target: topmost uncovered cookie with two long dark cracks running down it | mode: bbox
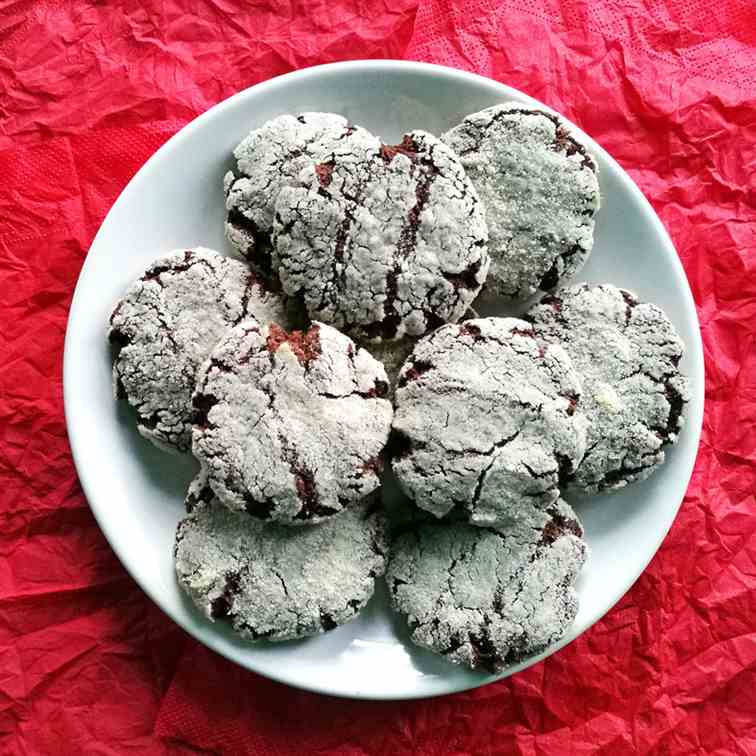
[273,131,488,341]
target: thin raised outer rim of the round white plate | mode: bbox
[63,59,705,701]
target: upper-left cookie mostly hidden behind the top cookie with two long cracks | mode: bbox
[223,113,380,269]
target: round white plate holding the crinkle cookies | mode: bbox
[64,61,704,698]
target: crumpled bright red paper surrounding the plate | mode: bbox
[0,0,756,756]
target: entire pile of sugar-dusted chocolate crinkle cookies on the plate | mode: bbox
[109,103,688,671]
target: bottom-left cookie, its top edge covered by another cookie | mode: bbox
[174,483,387,640]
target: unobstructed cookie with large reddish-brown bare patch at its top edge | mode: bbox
[192,320,393,524]
